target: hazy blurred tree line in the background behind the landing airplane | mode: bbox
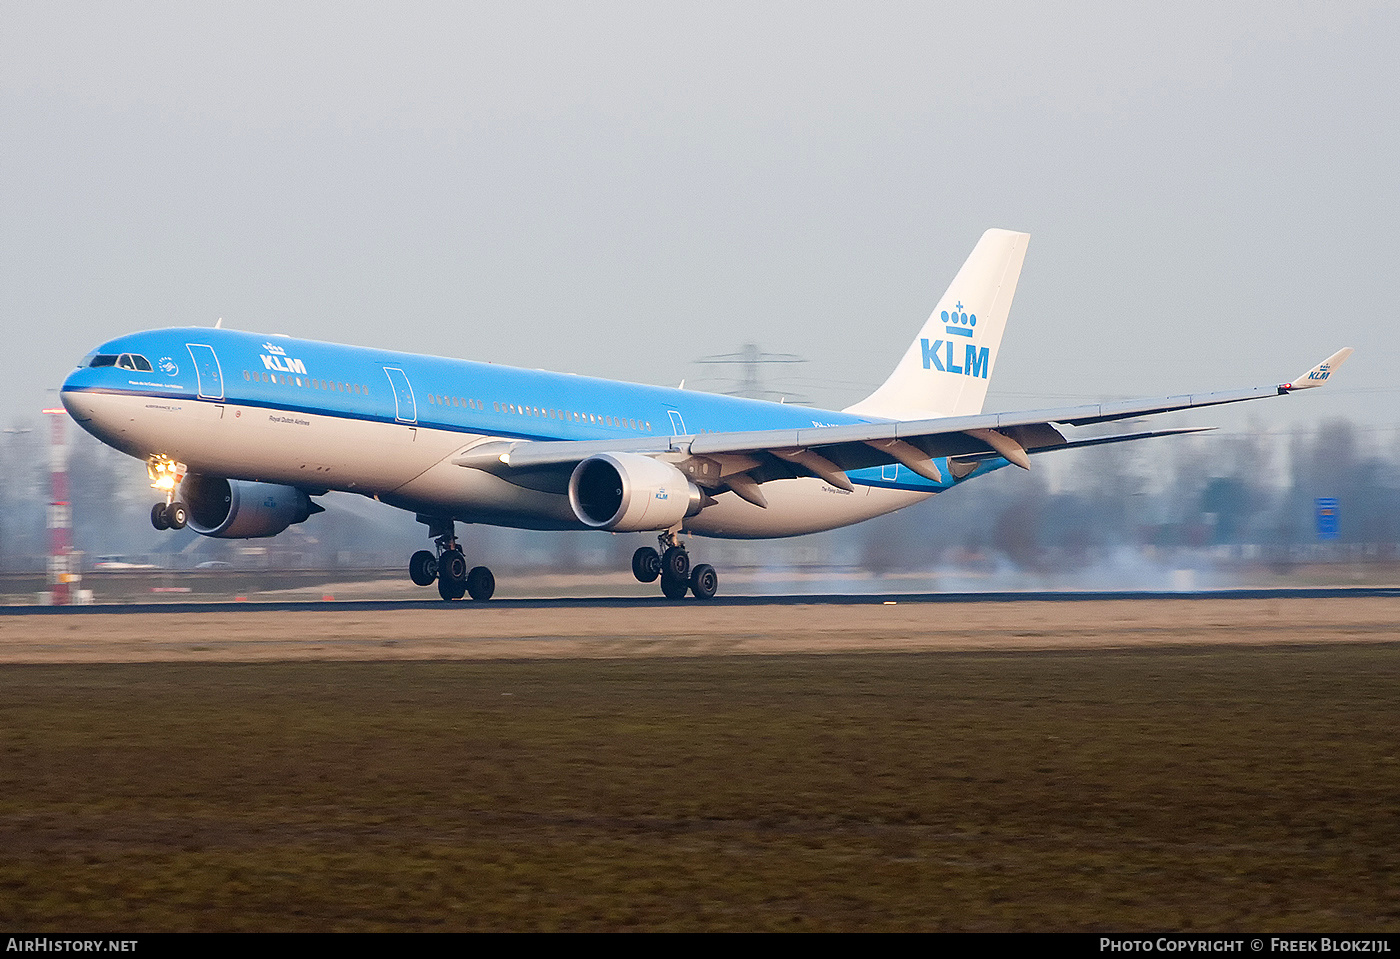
[0,420,1400,573]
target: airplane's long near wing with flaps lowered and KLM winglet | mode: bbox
[452,347,1351,500]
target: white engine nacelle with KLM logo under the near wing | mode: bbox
[568,452,704,533]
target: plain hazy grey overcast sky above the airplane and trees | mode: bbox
[0,0,1400,428]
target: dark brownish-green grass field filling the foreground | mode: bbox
[0,643,1400,931]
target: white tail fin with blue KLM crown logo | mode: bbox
[846,230,1030,420]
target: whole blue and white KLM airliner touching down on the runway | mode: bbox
[62,230,1351,601]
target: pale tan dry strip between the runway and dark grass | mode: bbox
[0,598,1400,662]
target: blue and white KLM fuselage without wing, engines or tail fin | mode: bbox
[63,328,963,538]
